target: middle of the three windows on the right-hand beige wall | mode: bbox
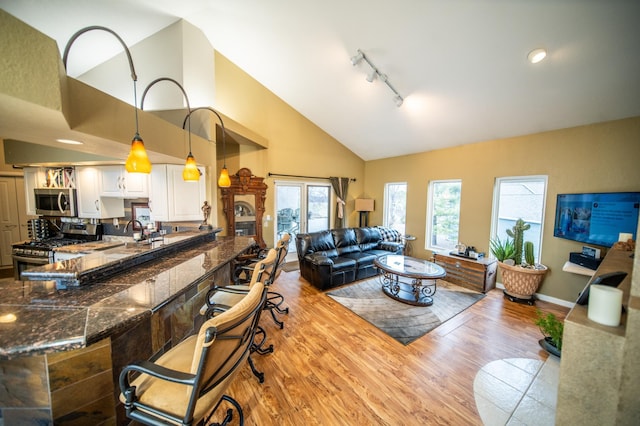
[426,180,462,250]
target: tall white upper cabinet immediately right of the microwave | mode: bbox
[76,167,124,219]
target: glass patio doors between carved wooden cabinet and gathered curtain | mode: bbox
[274,182,332,261]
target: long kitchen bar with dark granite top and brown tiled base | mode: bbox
[0,231,255,426]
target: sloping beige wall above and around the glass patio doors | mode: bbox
[214,53,364,246]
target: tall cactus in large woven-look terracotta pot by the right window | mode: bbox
[490,219,548,305]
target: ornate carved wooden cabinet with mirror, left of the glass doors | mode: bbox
[221,168,267,247]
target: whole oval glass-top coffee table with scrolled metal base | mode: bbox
[373,254,447,306]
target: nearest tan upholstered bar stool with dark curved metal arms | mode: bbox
[120,282,266,425]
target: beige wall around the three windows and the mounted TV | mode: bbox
[364,117,640,301]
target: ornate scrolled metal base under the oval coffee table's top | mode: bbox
[379,272,436,306]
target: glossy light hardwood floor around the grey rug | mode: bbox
[222,271,568,425]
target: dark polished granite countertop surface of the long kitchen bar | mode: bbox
[0,233,254,359]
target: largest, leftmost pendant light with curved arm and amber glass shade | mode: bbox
[62,25,151,173]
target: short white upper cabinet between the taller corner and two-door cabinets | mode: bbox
[98,166,149,198]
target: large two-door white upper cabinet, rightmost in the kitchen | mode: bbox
[149,164,206,222]
